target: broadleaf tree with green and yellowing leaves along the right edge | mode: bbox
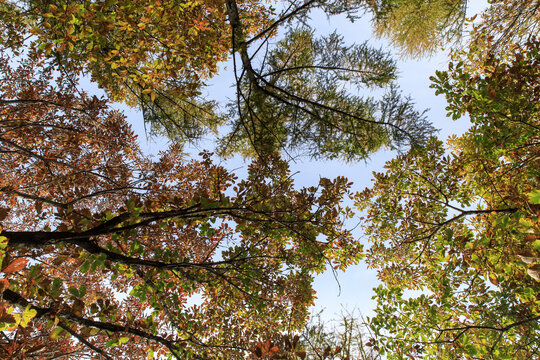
[357,37,540,359]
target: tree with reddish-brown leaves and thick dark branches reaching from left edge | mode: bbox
[0,54,361,359]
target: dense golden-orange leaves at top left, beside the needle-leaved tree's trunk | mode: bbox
[13,0,268,100]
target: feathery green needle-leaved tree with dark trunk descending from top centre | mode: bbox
[221,0,434,160]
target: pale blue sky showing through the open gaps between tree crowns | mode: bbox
[121,0,487,320]
